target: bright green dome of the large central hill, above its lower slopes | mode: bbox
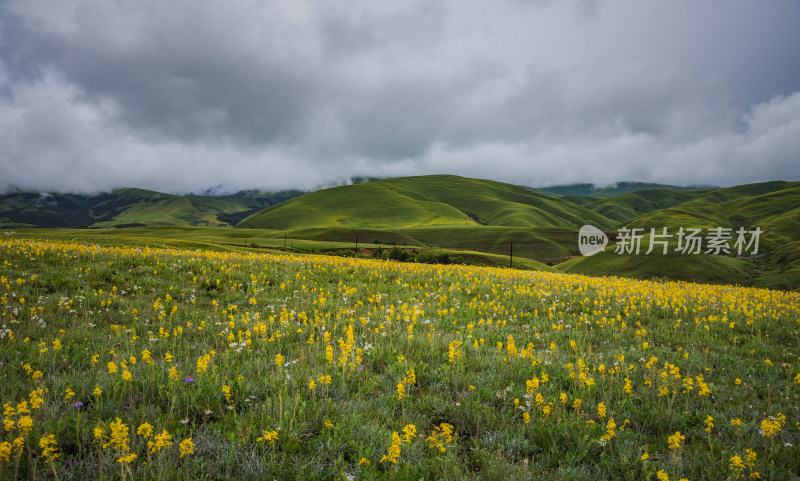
[237,175,612,230]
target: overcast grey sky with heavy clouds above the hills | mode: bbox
[0,0,800,193]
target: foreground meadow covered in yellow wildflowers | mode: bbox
[0,233,800,481]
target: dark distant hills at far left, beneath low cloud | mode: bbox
[0,188,301,228]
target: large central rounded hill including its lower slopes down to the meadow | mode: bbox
[237,175,615,264]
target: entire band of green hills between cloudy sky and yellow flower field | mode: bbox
[7,175,800,289]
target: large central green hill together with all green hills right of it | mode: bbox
[237,176,800,289]
